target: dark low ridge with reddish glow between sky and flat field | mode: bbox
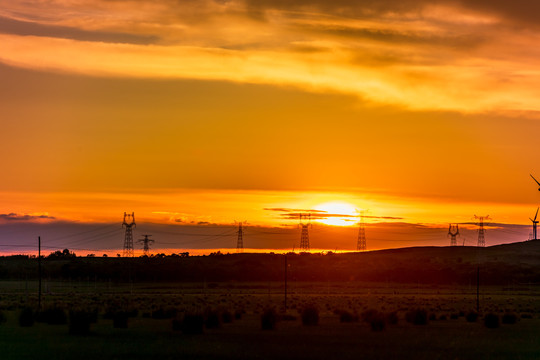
[0,241,540,285]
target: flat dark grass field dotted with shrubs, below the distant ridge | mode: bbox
[0,282,540,359]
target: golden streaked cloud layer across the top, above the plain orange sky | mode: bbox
[0,0,540,112]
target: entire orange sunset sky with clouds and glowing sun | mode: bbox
[0,0,540,252]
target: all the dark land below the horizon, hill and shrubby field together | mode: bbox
[0,241,540,360]
